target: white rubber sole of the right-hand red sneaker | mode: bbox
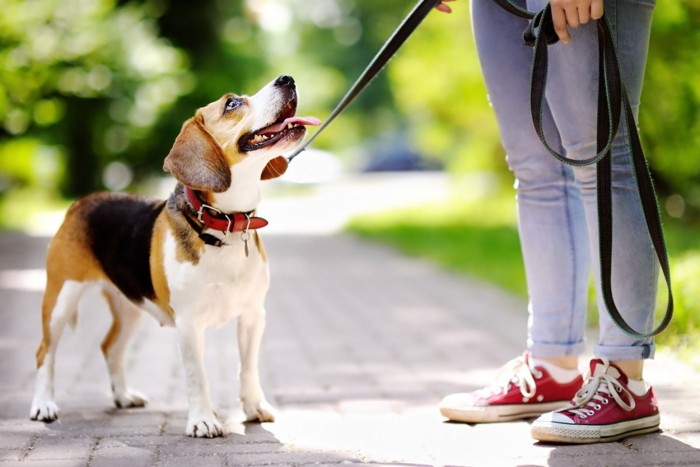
[531,414,661,444]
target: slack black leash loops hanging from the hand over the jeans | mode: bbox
[494,0,673,339]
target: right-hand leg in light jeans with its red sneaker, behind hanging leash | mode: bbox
[532,0,659,443]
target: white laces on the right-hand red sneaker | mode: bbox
[559,360,636,418]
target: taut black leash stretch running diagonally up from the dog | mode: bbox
[287,0,440,162]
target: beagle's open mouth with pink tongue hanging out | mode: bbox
[239,101,321,152]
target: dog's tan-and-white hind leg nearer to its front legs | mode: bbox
[102,287,146,409]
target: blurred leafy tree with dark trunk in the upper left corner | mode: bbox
[0,0,191,195]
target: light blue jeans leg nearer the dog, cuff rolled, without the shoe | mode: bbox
[472,0,590,365]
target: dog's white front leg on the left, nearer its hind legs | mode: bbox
[177,321,223,438]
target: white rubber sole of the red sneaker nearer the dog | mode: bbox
[440,400,569,423]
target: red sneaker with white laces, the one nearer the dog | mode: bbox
[440,352,583,423]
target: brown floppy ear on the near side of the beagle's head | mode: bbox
[163,114,231,193]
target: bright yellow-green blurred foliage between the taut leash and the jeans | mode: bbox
[389,5,505,173]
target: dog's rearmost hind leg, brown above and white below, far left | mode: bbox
[29,275,85,422]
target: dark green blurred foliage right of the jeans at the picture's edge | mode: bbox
[640,0,700,216]
